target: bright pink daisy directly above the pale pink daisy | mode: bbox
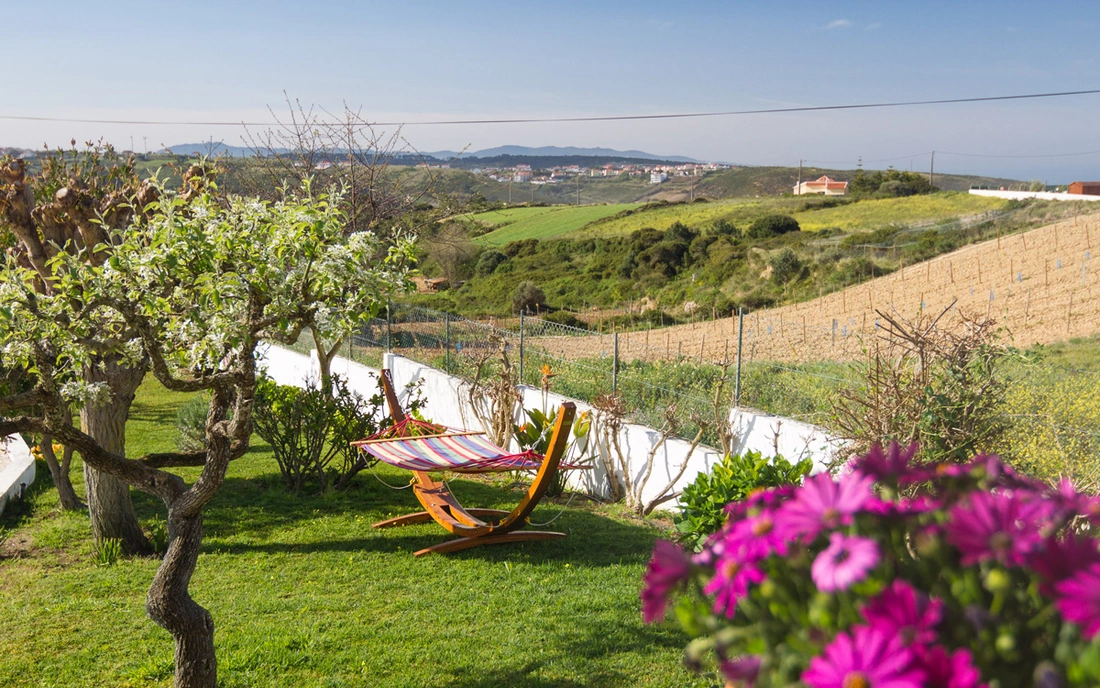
[776,472,875,542]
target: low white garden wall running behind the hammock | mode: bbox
[263,347,840,507]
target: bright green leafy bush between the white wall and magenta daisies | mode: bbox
[675,451,813,550]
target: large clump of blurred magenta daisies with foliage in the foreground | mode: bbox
[641,444,1100,688]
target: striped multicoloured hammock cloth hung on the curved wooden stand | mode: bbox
[353,418,581,473]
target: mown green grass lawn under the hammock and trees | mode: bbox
[0,382,705,687]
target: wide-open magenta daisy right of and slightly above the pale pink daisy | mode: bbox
[946,491,1052,566]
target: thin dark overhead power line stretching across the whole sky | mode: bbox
[0,89,1100,127]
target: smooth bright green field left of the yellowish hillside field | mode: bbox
[470,204,638,245]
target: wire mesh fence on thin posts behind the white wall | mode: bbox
[327,297,1100,478]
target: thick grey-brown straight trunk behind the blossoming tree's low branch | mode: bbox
[80,363,153,555]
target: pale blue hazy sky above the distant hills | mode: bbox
[8,0,1100,184]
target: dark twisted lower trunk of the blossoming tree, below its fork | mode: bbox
[145,507,218,688]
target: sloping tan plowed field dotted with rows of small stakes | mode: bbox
[529,215,1100,361]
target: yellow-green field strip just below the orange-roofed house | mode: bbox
[794,192,1008,231]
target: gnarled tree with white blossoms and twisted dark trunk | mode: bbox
[0,167,410,688]
